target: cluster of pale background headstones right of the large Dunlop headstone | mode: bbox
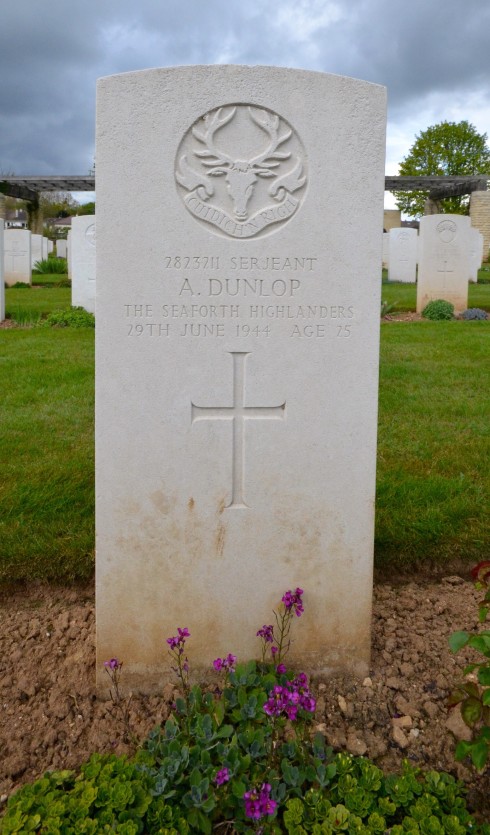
[383,215,484,312]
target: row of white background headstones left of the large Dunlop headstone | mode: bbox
[0,215,95,319]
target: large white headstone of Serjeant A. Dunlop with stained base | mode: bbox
[96,66,385,691]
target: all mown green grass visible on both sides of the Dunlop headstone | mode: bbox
[0,285,490,582]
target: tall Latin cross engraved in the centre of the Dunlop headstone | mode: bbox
[191,351,286,508]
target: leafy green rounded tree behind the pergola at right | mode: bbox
[396,121,490,217]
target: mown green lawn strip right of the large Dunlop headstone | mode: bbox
[376,321,490,569]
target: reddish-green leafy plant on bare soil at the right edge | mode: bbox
[449,560,490,771]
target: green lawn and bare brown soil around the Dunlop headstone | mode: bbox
[0,276,490,820]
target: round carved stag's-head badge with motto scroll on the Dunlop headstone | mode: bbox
[175,104,307,238]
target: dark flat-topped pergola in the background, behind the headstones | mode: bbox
[0,174,488,232]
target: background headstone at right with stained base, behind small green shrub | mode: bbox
[417,214,471,313]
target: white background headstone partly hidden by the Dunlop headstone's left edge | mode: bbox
[70,215,95,313]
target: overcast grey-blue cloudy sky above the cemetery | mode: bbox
[0,0,490,206]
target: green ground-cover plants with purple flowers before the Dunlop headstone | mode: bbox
[1,588,490,835]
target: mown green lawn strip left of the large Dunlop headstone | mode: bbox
[0,326,94,581]
